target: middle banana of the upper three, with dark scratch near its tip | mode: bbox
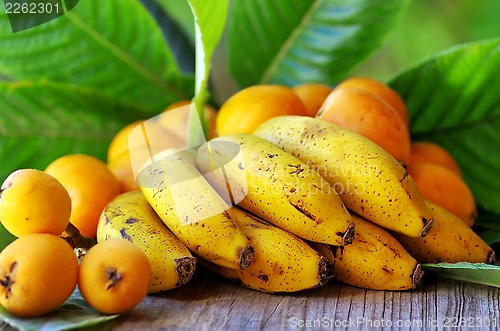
[196,134,354,245]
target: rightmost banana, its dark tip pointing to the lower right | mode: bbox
[394,201,495,263]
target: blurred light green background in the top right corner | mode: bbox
[354,0,500,80]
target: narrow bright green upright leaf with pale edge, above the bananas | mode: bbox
[188,0,229,146]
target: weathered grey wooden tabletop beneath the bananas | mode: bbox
[0,270,500,331]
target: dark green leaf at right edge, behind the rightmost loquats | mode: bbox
[389,39,500,214]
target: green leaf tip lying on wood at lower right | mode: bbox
[422,262,500,287]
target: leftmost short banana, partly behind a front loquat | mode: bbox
[97,191,196,293]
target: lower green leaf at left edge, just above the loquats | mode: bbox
[0,81,145,182]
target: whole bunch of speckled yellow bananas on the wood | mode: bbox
[98,116,494,293]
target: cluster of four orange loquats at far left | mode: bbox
[0,160,151,317]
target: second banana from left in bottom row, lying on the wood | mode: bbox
[200,208,334,293]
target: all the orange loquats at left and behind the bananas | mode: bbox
[0,77,477,317]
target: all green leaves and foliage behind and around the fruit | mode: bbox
[0,0,500,329]
